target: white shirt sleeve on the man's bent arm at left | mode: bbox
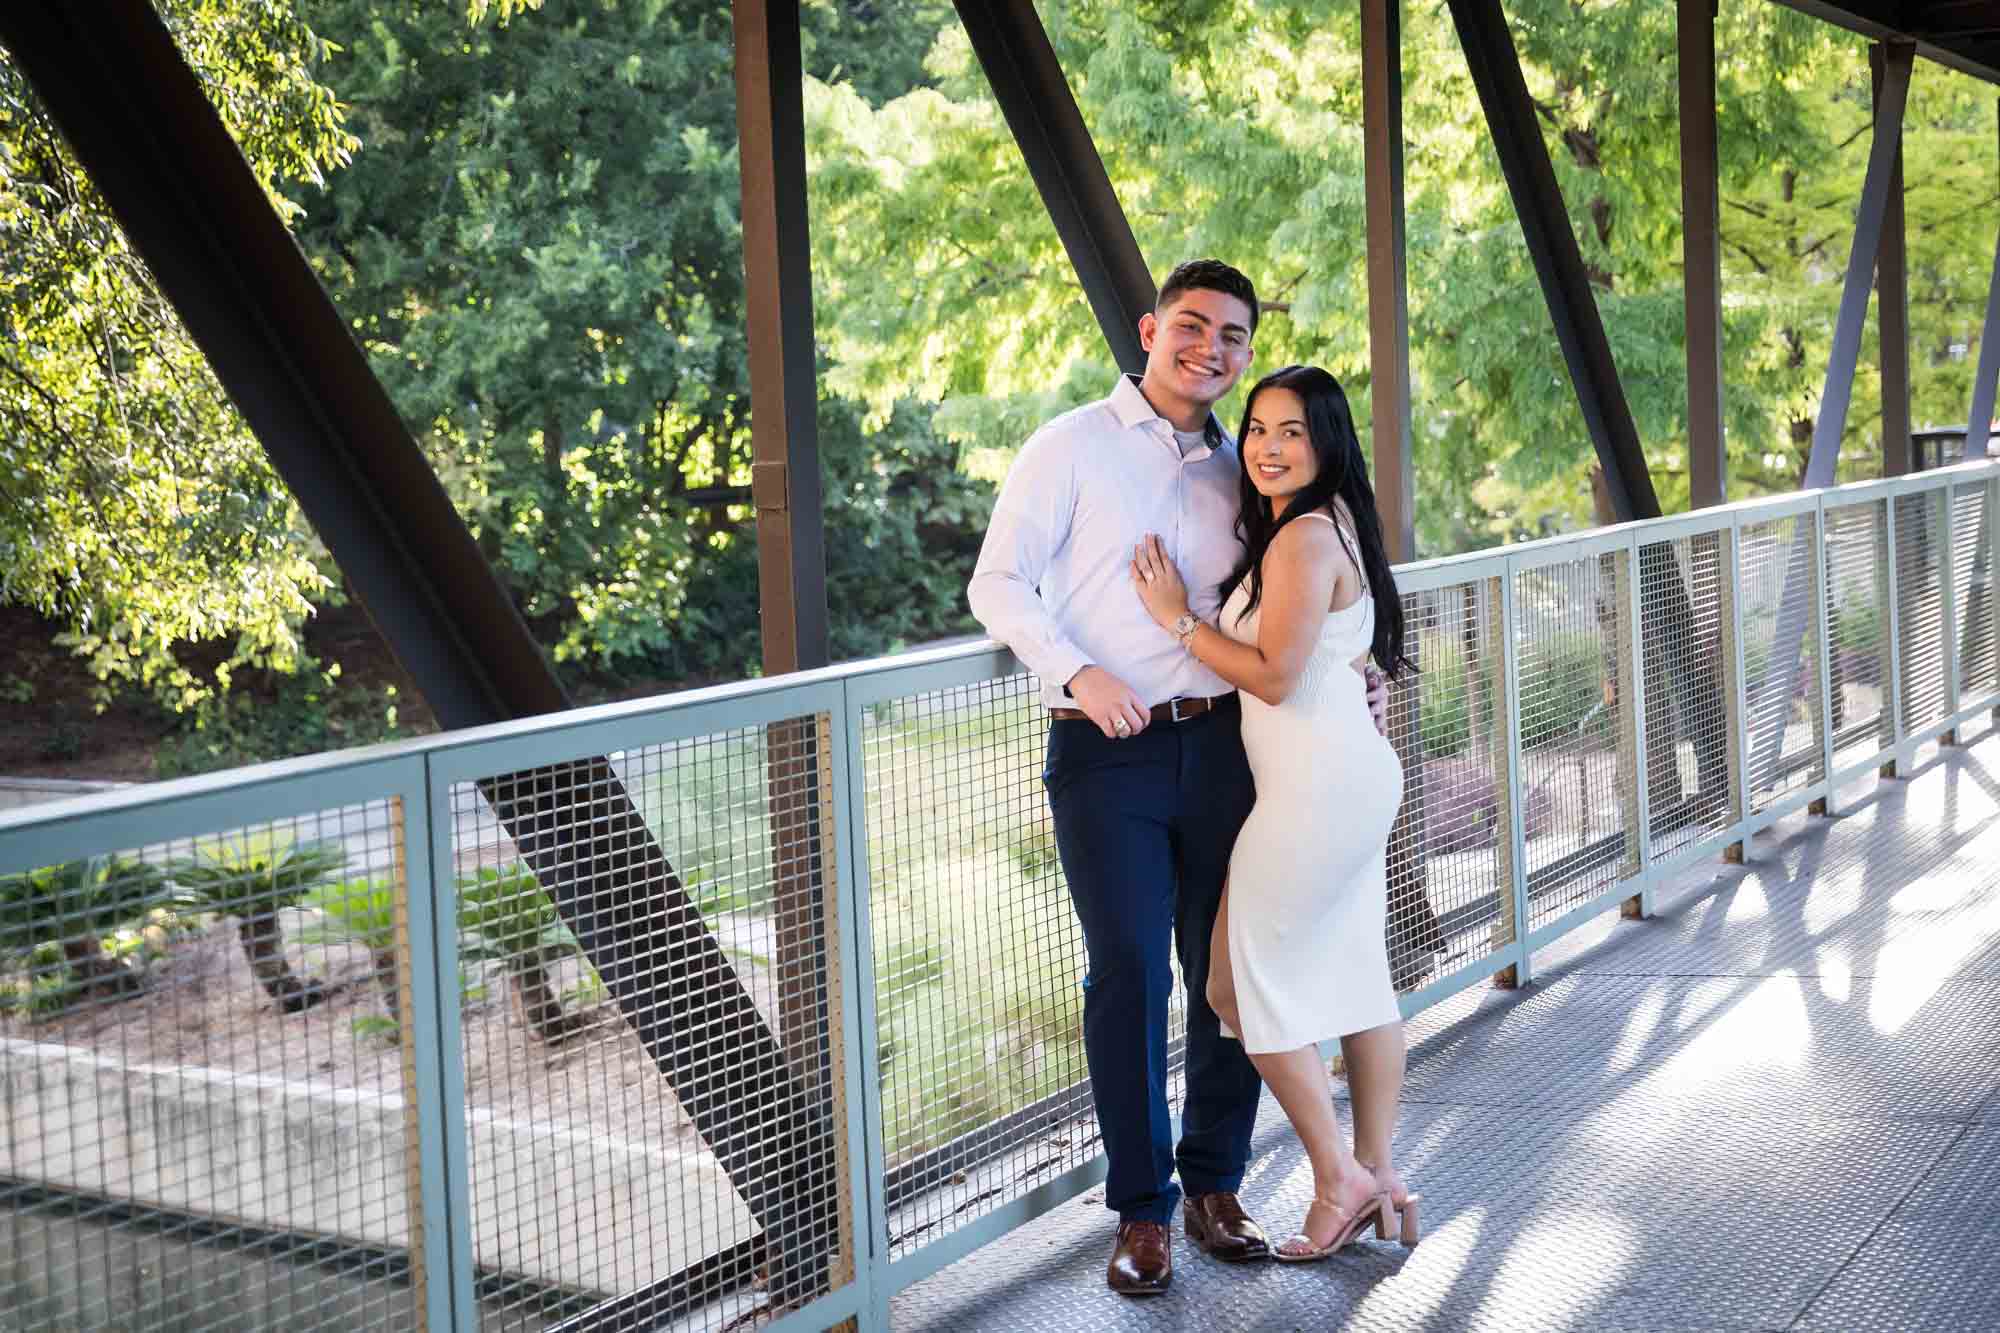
[966,434,1090,685]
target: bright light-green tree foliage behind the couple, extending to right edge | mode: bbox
[808,0,1992,552]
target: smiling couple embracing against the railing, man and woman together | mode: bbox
[970,260,1418,1295]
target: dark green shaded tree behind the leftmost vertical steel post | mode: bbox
[298,0,982,675]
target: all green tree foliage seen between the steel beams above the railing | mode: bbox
[0,0,1994,728]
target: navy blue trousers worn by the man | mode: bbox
[1042,703,1262,1223]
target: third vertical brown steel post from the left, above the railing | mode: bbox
[1676,0,1730,508]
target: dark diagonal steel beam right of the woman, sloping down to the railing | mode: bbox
[1450,0,1660,520]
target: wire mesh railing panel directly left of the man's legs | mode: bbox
[862,675,1112,1257]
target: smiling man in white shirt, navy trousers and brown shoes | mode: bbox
[968,260,1382,1295]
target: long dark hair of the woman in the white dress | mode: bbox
[1222,366,1416,677]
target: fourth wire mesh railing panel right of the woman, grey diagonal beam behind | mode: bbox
[1738,510,1826,811]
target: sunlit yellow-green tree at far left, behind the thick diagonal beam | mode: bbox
[0,0,354,707]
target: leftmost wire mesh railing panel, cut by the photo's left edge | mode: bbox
[0,799,426,1333]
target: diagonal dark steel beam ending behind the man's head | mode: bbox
[954,0,1158,374]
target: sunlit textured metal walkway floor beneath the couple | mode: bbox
[894,731,2000,1333]
